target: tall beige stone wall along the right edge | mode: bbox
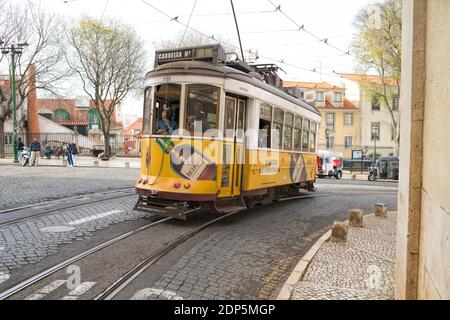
[396,0,450,299]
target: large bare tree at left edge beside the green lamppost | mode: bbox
[0,0,67,157]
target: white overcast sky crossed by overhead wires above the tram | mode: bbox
[42,0,373,114]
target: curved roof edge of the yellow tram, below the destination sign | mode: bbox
[146,61,320,115]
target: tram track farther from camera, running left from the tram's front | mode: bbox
[0,188,136,228]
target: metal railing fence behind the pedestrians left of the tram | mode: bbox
[3,132,141,157]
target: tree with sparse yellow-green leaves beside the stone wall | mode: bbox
[352,0,402,153]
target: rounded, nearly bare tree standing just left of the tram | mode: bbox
[66,18,146,158]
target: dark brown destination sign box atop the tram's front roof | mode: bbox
[155,44,225,67]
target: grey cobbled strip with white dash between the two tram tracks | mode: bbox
[0,197,143,273]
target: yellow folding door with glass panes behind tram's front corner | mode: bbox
[219,97,246,197]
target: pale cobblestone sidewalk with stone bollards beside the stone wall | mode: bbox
[291,212,397,300]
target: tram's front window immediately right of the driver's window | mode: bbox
[186,85,219,135]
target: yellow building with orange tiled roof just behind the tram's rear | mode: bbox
[283,81,361,159]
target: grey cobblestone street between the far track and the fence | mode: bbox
[0,165,138,210]
